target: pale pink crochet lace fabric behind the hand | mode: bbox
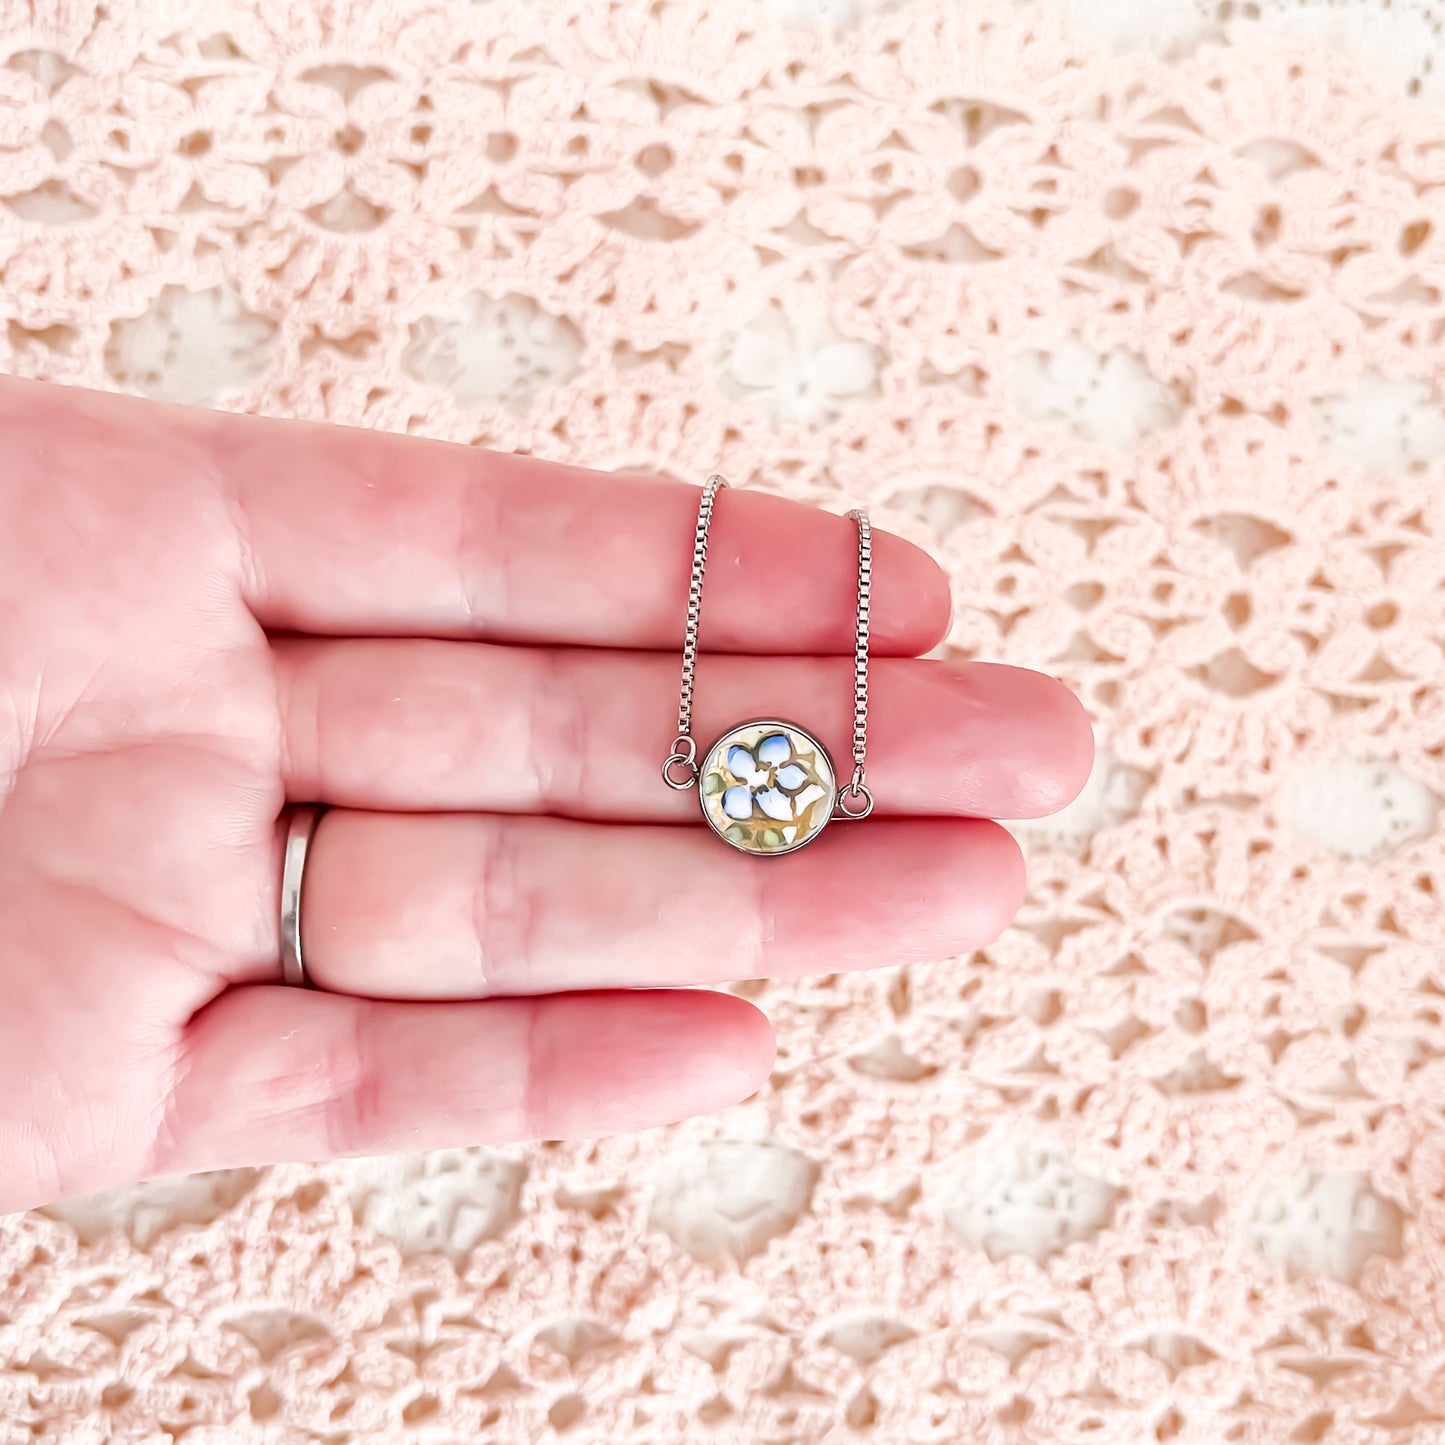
[0,0,1445,1445]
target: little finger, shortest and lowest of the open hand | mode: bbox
[153,987,773,1173]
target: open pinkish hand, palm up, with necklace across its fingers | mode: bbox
[0,380,1091,1209]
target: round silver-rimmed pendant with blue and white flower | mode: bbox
[698,718,838,858]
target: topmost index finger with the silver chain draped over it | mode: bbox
[192,395,949,655]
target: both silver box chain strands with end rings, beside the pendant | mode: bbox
[662,474,873,819]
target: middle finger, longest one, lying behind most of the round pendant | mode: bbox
[276,640,1094,822]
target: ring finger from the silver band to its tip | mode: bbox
[293,811,1023,998]
